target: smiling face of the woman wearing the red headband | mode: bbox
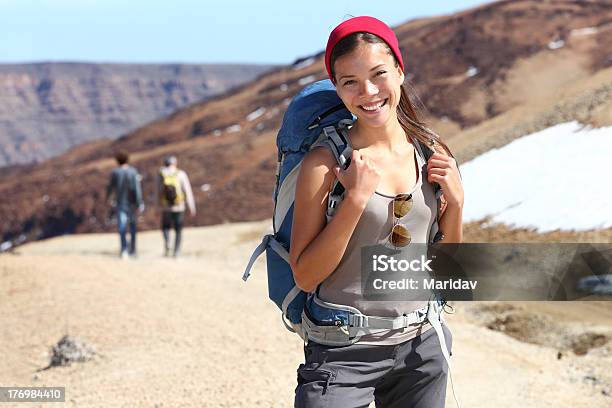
[334,43,404,127]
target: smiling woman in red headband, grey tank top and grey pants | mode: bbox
[289,17,463,408]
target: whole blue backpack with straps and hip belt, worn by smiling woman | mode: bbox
[242,80,448,344]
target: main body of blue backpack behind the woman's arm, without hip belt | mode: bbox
[243,80,353,331]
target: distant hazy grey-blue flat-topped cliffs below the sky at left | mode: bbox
[0,63,270,167]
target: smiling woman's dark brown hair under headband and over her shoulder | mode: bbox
[330,32,450,155]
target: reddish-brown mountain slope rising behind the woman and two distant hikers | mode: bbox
[0,0,612,243]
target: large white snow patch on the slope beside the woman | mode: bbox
[461,121,612,232]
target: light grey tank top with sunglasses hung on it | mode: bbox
[319,142,436,345]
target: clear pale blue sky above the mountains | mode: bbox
[0,0,486,64]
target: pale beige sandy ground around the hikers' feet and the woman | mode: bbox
[0,221,612,408]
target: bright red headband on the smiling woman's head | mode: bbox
[325,16,404,82]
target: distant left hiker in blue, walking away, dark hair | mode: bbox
[106,151,145,259]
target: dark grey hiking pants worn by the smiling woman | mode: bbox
[295,324,452,408]
